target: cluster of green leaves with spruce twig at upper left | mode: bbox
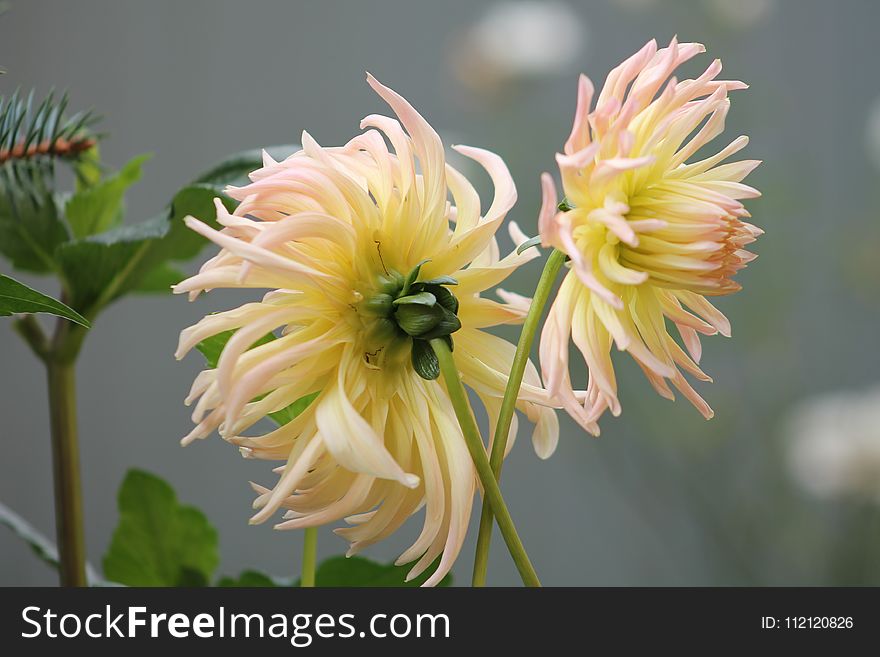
[0,93,294,326]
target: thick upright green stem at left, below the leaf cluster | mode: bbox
[46,354,88,586]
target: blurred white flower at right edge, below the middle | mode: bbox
[786,386,880,503]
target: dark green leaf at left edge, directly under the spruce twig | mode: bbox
[0,184,70,273]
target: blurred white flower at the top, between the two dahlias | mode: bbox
[452,0,586,91]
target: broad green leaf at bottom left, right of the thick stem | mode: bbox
[104,470,220,586]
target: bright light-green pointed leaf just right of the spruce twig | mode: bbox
[64,155,150,238]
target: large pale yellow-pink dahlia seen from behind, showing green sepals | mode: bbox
[175,76,558,585]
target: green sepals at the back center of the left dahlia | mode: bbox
[357,261,461,380]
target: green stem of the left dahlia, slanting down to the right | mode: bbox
[431,338,541,586]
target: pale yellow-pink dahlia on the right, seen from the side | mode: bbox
[539,39,762,435]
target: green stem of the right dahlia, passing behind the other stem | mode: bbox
[472,250,565,586]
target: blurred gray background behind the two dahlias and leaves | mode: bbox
[0,0,880,585]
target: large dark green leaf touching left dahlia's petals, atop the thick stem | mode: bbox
[56,185,235,316]
